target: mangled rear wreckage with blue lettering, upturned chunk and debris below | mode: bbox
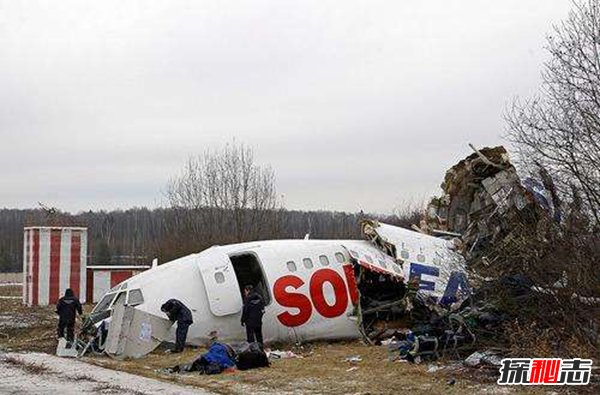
[362,146,560,365]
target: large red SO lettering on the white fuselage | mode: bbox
[273,265,358,327]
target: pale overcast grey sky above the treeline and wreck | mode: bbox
[0,0,570,212]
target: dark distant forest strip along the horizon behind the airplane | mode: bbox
[0,208,418,272]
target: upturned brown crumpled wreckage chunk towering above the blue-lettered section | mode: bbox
[421,146,560,258]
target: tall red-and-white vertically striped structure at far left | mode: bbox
[23,226,87,306]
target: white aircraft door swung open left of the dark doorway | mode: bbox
[197,247,242,317]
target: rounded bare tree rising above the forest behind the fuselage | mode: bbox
[166,142,280,242]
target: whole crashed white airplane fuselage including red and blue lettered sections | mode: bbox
[94,223,465,356]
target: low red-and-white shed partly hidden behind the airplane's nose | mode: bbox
[87,265,151,303]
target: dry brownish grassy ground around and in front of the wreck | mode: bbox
[0,286,593,394]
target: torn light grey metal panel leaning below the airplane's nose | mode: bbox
[106,304,173,358]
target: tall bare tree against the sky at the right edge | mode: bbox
[506,0,600,226]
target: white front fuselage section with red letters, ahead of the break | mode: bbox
[96,231,466,344]
